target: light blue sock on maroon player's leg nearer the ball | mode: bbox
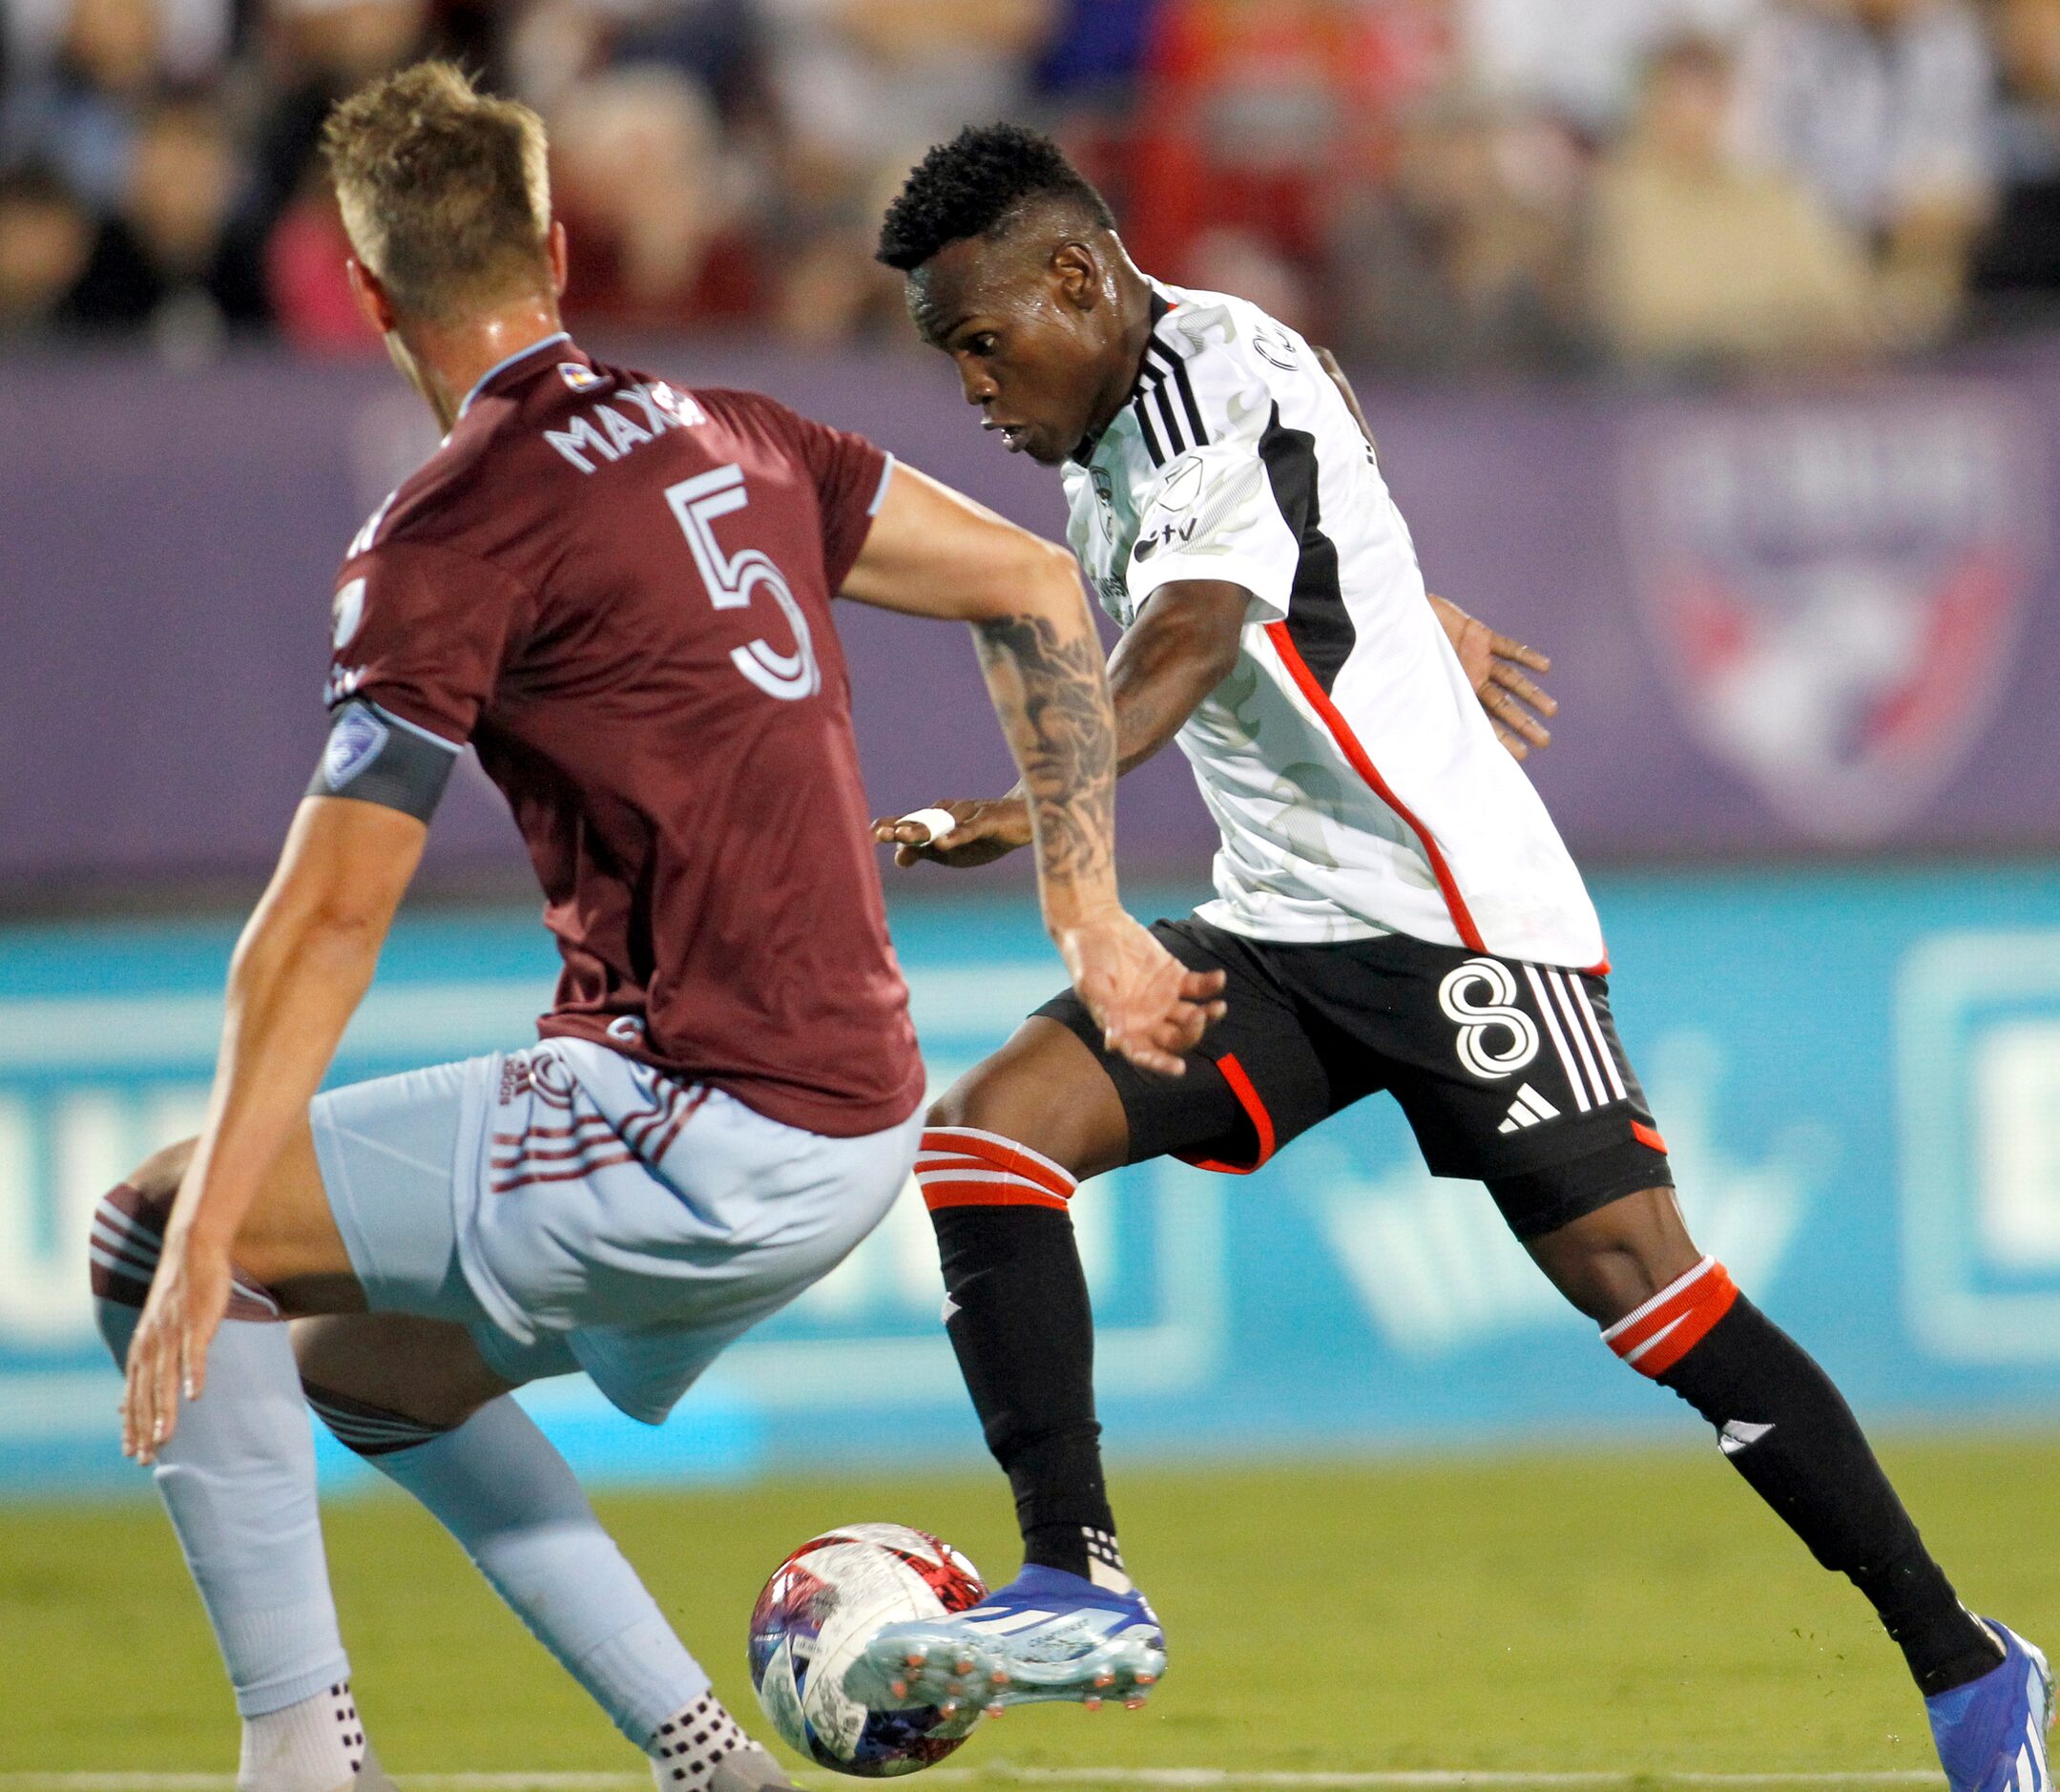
[307,1388,709,1749]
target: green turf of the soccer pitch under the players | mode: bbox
[0,1440,2060,1786]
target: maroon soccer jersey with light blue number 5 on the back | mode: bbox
[327,338,923,1137]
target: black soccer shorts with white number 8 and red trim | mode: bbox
[1038,919,1673,1238]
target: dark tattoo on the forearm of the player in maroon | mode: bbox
[972,615,1116,887]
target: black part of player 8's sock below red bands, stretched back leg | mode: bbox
[1658,1294,2000,1696]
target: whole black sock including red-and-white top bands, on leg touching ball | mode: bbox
[917,1127,1129,1590]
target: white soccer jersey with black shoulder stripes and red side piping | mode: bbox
[1065,286,1603,966]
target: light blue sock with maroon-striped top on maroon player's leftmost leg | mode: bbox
[93,1189,350,1718]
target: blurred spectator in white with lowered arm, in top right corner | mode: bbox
[1743,0,1998,338]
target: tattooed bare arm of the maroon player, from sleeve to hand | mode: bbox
[844,466,1223,1075]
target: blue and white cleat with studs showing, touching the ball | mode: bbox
[844,1566,1166,1714]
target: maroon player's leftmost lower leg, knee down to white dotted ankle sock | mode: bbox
[91,1170,389,1792]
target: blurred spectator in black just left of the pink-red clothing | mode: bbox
[66,99,266,354]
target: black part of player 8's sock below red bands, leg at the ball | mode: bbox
[931,1207,1123,1578]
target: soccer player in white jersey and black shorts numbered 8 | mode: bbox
[855,126,2051,1792]
